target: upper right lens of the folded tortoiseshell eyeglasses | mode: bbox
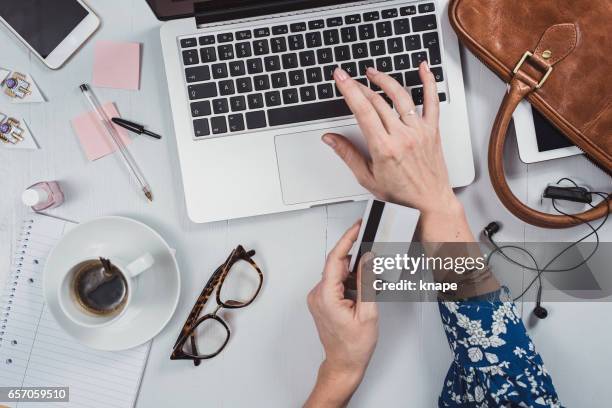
[219,260,261,306]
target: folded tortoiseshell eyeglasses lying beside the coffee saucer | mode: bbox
[170,245,263,366]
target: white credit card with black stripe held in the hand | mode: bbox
[349,199,421,282]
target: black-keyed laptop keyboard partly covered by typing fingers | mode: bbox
[178,2,447,139]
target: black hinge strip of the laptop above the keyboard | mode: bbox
[194,0,347,27]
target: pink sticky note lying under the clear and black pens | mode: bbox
[72,102,130,161]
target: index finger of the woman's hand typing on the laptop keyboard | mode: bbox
[334,68,387,150]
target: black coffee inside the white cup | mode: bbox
[72,260,128,316]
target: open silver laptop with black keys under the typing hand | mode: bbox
[155,0,474,223]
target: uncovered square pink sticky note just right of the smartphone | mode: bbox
[92,41,140,90]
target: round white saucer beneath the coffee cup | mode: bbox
[43,217,181,351]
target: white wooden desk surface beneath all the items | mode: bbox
[0,0,612,408]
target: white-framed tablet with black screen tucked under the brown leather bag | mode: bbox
[513,101,582,163]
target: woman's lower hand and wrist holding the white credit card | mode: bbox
[306,222,378,407]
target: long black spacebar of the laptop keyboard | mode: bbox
[268,99,351,126]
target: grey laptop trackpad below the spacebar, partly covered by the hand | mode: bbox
[274,125,368,205]
